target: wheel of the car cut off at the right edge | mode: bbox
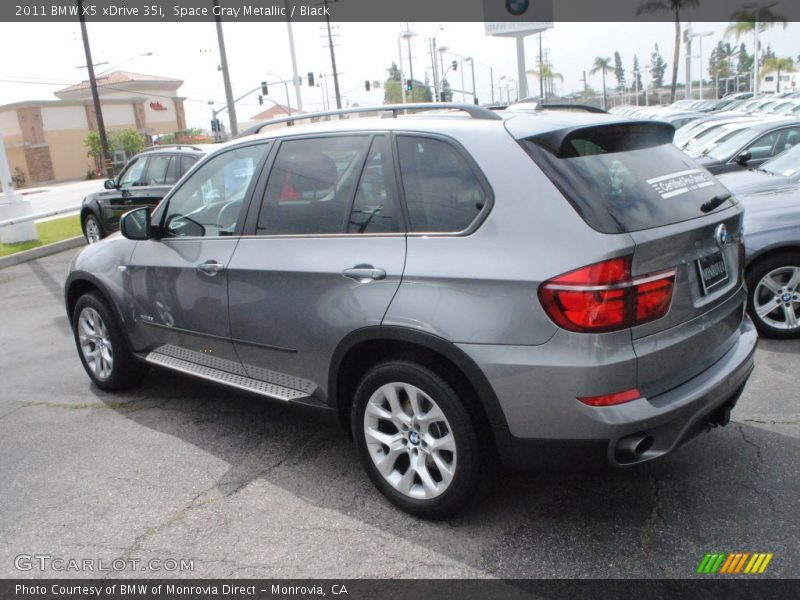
[747,252,800,339]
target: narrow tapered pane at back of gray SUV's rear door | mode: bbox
[347,136,402,233]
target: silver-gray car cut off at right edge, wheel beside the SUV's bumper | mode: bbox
[739,187,800,339]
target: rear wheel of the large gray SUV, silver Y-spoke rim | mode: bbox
[350,360,481,519]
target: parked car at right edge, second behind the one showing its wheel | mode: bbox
[699,118,800,175]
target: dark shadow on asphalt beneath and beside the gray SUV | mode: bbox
[101,372,800,577]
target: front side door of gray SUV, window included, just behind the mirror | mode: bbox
[127,142,268,374]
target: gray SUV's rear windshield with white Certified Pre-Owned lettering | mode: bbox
[522,130,733,233]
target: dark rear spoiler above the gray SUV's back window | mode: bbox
[527,120,675,158]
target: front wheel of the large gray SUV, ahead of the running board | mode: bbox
[72,292,147,391]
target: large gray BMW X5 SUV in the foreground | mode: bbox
[66,105,757,518]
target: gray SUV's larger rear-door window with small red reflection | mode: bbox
[256,136,370,235]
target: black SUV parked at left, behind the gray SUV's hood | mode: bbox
[81,145,210,244]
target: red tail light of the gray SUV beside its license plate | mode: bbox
[539,256,675,333]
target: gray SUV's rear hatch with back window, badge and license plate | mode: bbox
[507,121,744,397]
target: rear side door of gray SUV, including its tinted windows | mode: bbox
[228,134,406,400]
